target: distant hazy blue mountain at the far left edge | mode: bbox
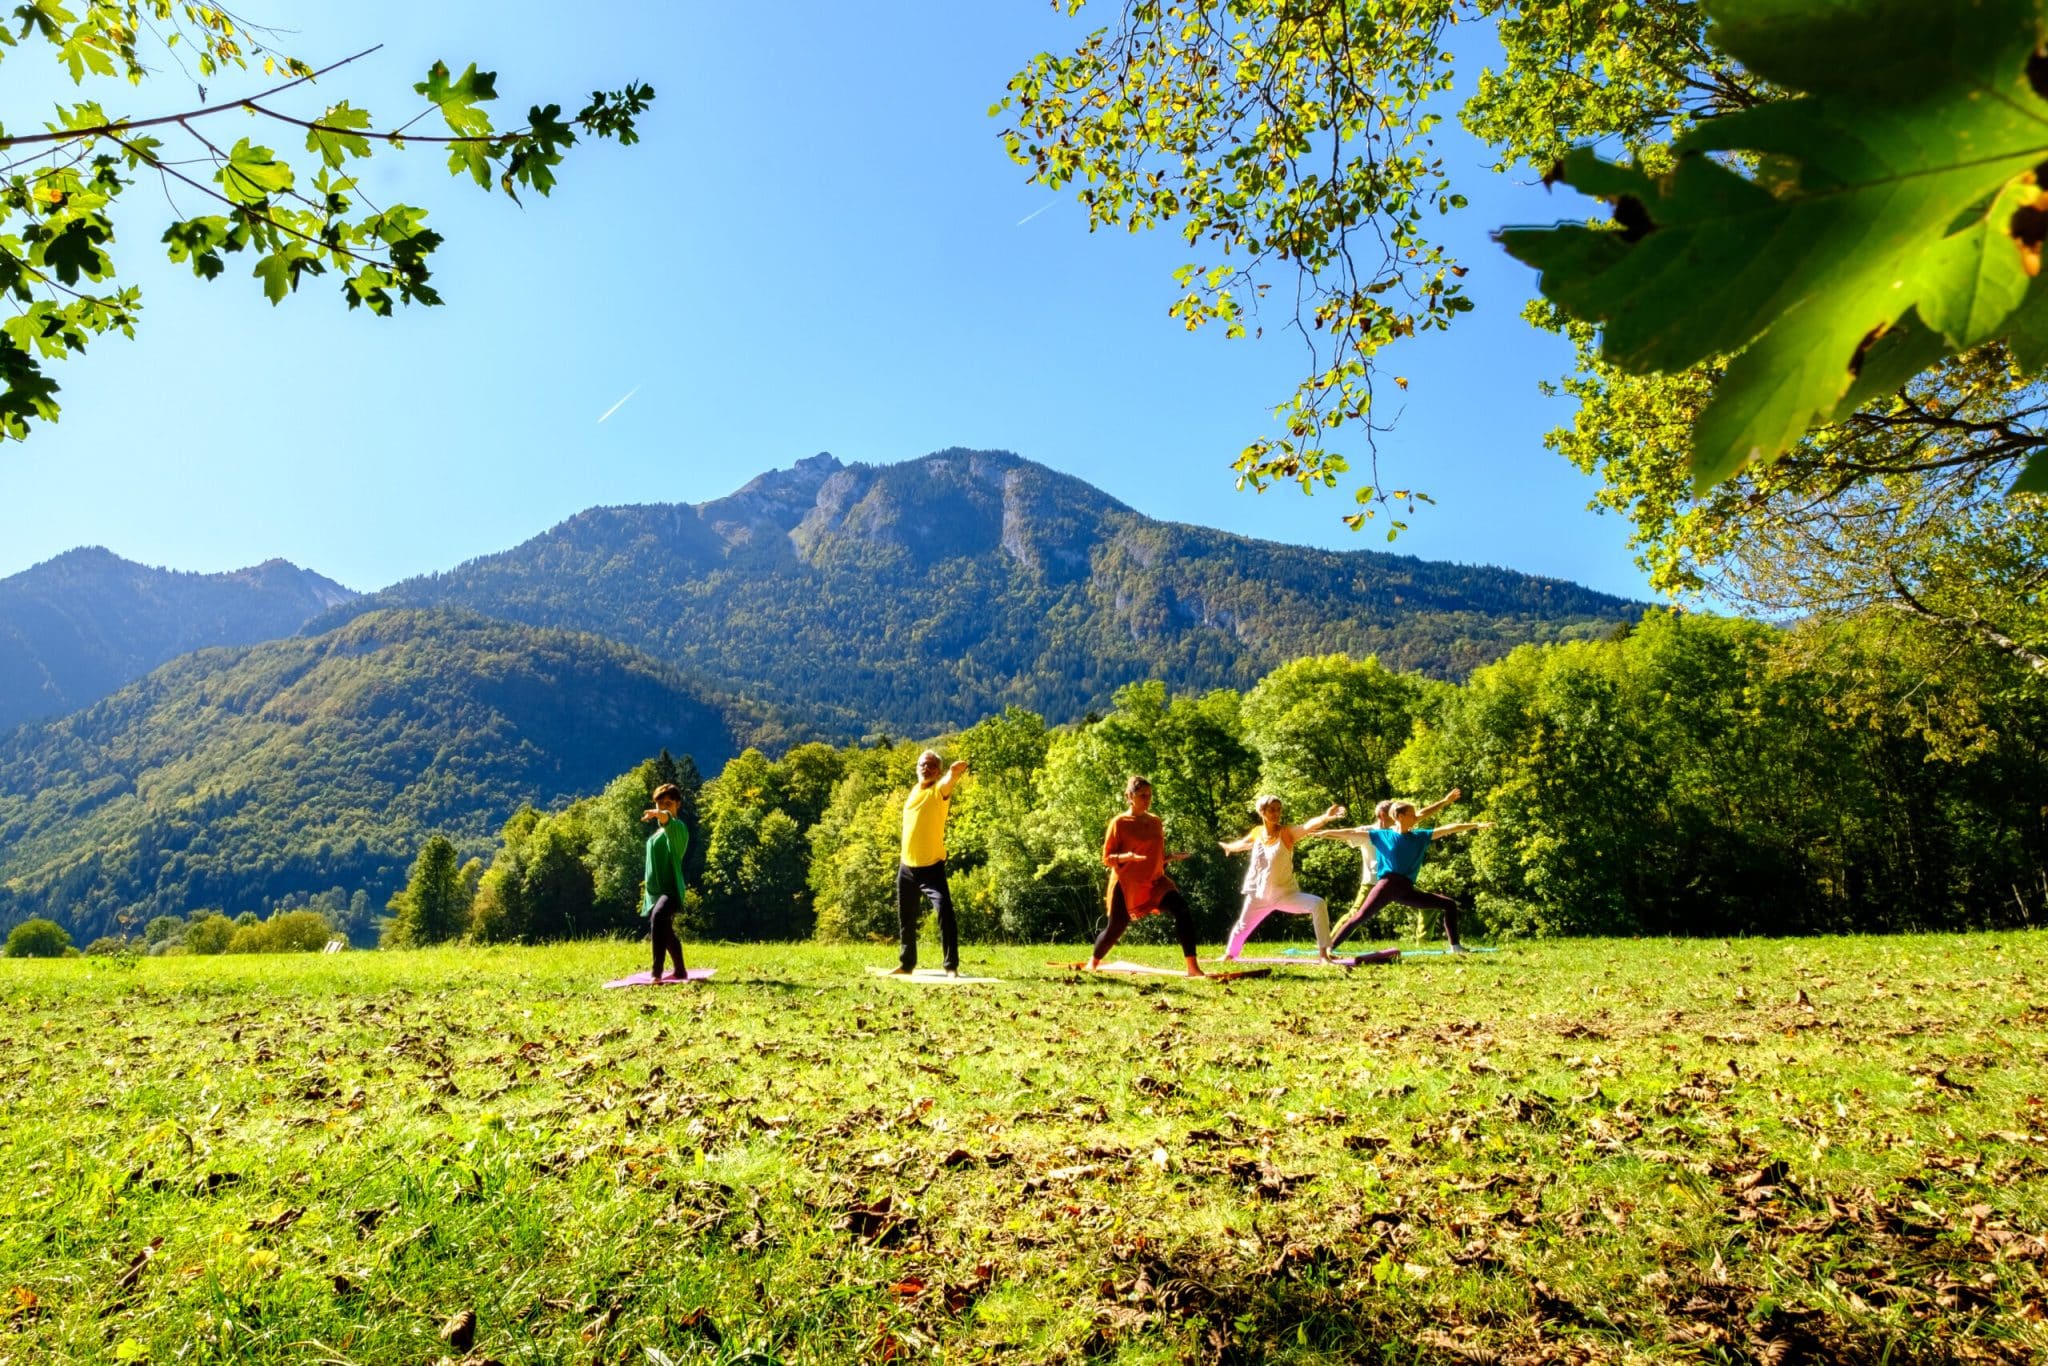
[0,547,356,731]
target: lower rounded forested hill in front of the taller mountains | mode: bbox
[0,610,750,942]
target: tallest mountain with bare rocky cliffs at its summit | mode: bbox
[339,451,1640,735]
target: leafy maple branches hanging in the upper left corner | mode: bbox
[0,0,653,440]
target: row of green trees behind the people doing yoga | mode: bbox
[387,612,2048,944]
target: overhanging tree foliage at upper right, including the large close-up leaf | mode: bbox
[995,0,2048,684]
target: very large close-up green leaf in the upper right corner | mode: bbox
[1501,0,2048,489]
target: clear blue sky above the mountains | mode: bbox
[0,0,1645,594]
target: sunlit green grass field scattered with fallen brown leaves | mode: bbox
[0,934,2048,1366]
